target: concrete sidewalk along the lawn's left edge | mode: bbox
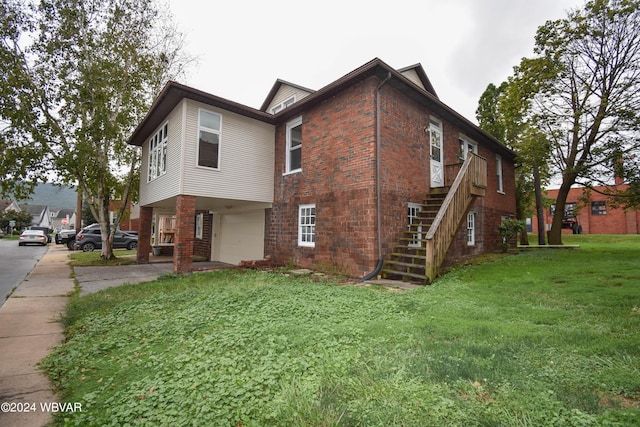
[0,246,74,427]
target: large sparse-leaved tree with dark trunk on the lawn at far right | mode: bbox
[530,0,640,244]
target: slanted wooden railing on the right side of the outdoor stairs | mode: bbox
[425,153,487,283]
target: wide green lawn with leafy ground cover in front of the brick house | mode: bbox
[43,235,640,426]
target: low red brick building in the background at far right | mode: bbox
[531,178,640,234]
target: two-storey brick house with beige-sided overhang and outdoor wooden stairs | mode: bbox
[129,59,515,282]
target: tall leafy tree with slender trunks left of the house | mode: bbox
[0,0,189,258]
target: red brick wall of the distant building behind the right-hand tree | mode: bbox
[532,188,640,234]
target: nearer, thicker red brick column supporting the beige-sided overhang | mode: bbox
[173,195,196,273]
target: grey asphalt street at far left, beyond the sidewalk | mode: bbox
[0,236,48,306]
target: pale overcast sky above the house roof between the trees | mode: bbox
[169,0,584,123]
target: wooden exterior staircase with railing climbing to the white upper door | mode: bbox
[381,154,487,285]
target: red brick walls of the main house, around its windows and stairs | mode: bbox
[265,77,515,276]
